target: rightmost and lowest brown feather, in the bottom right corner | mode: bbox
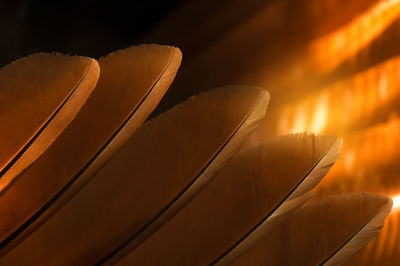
[233,193,392,266]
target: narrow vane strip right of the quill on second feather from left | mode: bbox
[0,47,182,258]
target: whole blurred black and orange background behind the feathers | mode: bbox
[0,0,400,265]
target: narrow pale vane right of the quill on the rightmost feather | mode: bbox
[320,196,393,266]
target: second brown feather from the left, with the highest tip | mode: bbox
[0,45,181,254]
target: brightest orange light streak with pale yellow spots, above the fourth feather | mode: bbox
[276,57,400,135]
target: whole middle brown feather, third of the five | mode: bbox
[0,86,269,265]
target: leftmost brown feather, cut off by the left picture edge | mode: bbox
[0,53,100,195]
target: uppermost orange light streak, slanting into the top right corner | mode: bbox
[311,0,400,69]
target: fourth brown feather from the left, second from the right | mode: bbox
[115,134,340,265]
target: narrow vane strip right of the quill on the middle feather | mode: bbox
[100,88,270,265]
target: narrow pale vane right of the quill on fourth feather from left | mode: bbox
[212,136,342,265]
